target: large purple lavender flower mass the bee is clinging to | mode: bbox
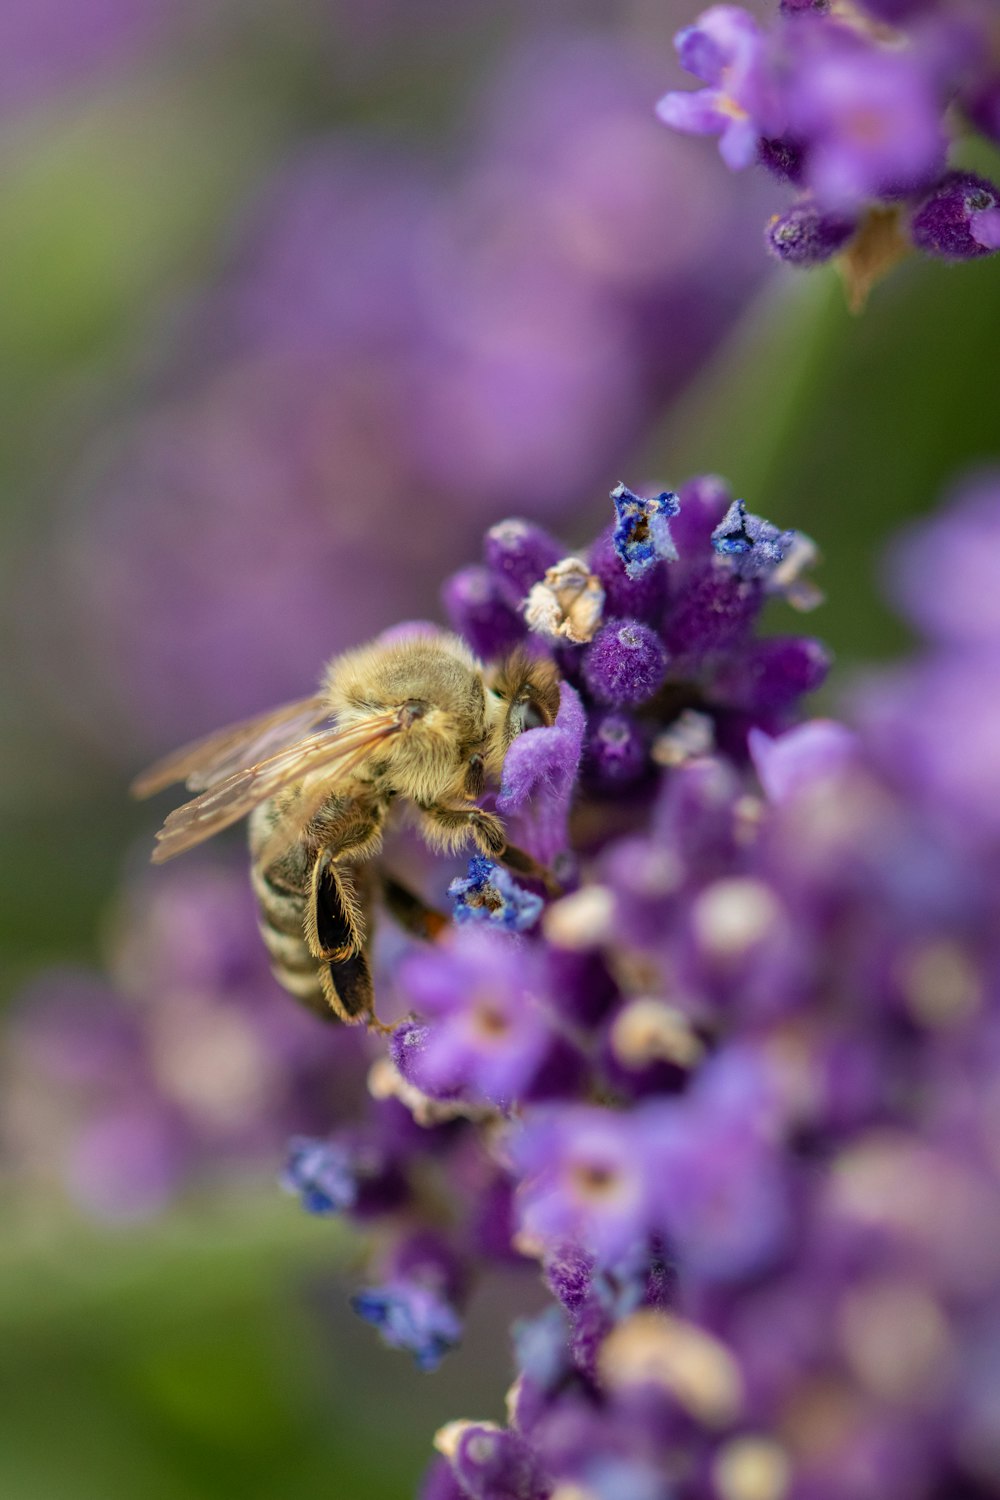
[275,476,1000,1500]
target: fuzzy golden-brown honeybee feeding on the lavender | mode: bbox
[132,630,559,1028]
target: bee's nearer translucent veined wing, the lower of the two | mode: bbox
[153,710,403,864]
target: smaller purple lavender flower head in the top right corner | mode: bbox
[657,0,1000,275]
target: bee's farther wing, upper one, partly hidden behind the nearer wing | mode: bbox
[132,693,330,797]
